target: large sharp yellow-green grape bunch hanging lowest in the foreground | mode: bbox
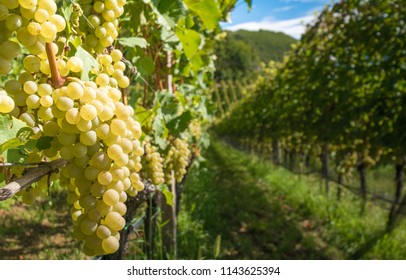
[15,68,144,255]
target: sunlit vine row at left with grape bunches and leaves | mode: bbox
[0,0,250,258]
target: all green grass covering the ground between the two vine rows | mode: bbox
[179,141,406,259]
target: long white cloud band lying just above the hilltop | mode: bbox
[224,15,315,39]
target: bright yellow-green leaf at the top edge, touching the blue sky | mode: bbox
[183,0,221,30]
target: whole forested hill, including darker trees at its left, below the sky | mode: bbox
[216,30,296,81]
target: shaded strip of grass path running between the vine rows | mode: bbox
[181,139,340,259]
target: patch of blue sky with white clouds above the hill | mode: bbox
[221,0,337,39]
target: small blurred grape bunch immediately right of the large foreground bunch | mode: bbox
[141,138,165,185]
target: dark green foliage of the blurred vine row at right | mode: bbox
[217,0,406,228]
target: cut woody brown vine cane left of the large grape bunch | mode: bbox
[0,159,67,201]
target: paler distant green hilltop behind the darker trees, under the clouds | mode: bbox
[228,30,296,62]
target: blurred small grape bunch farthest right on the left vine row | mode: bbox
[164,138,191,185]
